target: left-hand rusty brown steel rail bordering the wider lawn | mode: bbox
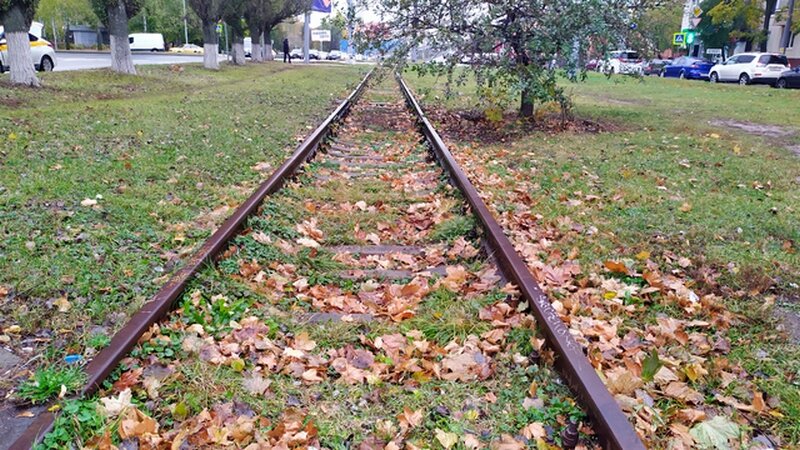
[9,68,375,450]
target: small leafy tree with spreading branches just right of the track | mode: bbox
[379,0,641,117]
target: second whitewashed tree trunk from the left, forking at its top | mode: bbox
[92,0,142,75]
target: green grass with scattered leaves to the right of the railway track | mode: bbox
[406,73,800,445]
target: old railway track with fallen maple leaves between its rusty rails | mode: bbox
[11,71,643,449]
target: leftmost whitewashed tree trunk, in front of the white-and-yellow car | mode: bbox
[0,0,41,87]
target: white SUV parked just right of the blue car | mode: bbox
[708,53,791,85]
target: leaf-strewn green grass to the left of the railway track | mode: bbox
[0,64,361,394]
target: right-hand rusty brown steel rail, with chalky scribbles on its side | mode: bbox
[395,74,645,450]
